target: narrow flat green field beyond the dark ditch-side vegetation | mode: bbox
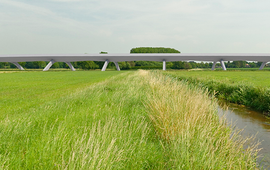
[167,69,270,87]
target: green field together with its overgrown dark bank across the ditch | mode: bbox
[164,71,270,115]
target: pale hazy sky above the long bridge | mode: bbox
[0,0,270,54]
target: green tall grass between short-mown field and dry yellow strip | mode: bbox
[0,73,164,169]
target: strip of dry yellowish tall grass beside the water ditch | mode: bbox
[141,71,258,169]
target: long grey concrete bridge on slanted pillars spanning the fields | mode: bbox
[0,53,270,71]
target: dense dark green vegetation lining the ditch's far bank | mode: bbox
[166,75,270,115]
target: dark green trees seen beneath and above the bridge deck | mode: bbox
[0,47,267,70]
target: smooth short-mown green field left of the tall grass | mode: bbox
[0,71,123,118]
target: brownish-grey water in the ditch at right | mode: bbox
[218,102,270,170]
